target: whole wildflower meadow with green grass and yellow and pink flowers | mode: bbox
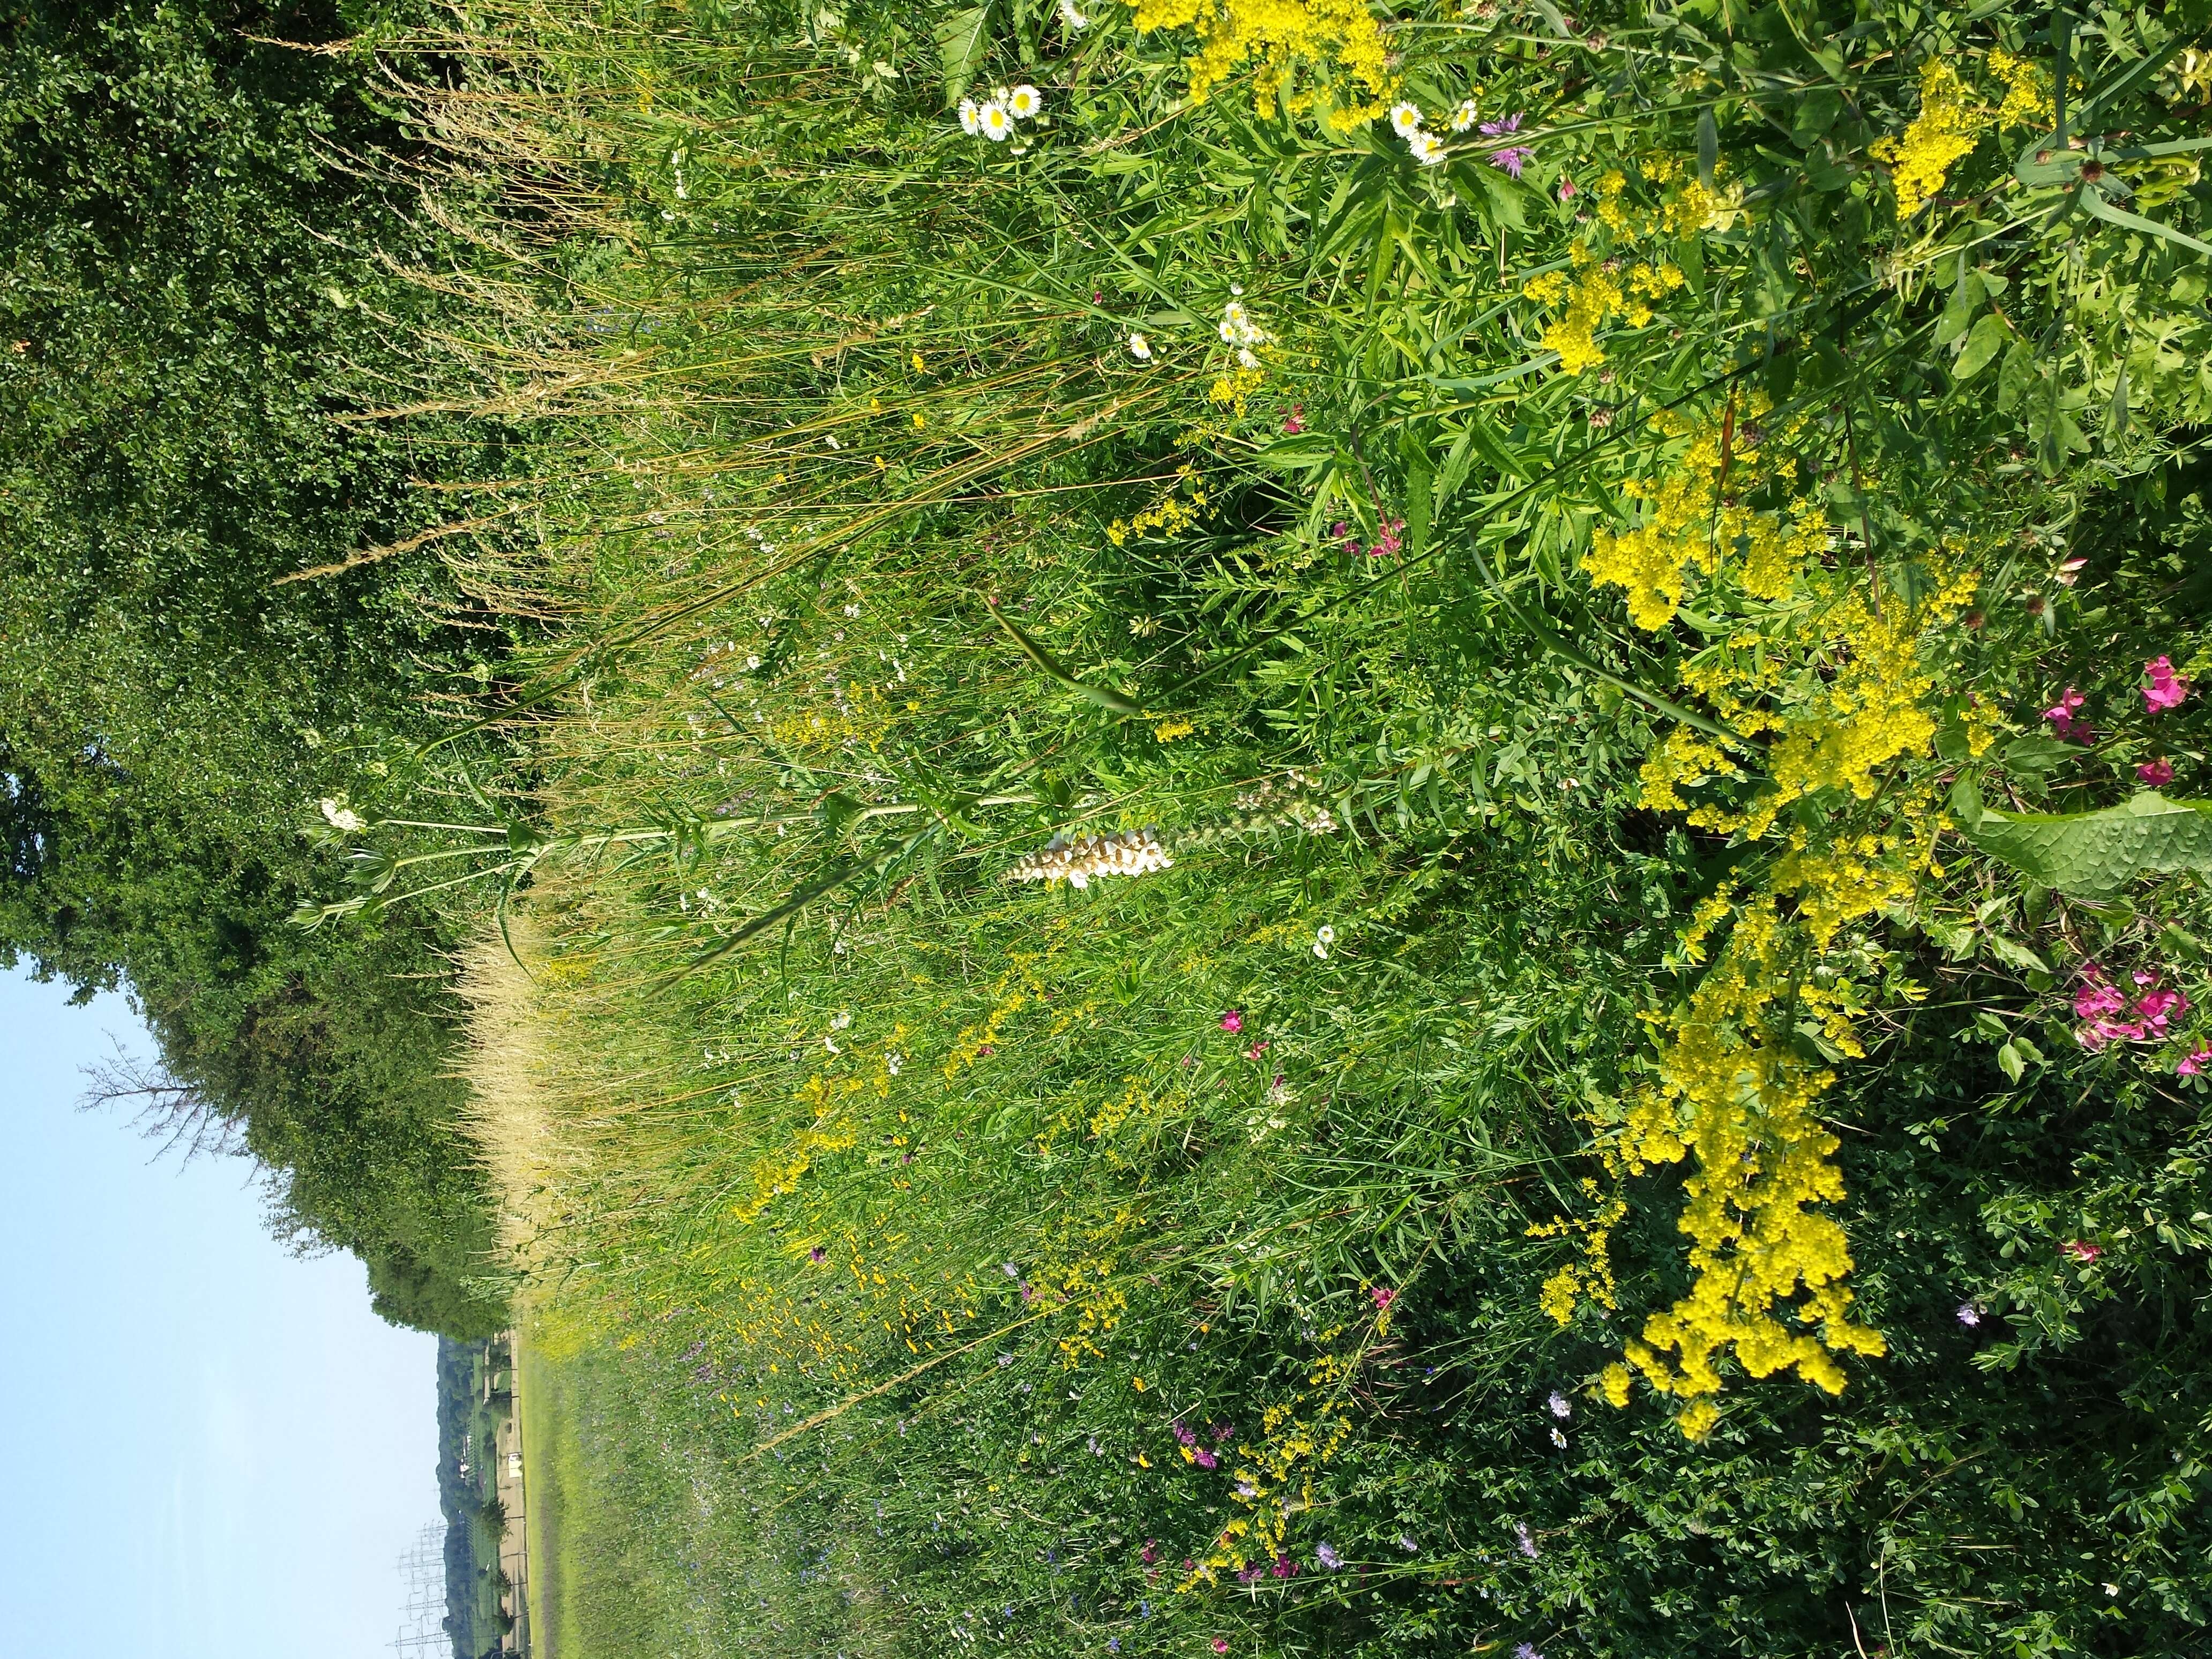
[327,0,2212,1659]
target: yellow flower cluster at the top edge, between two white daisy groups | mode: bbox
[1137,0,1398,126]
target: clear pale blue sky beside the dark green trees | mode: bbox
[0,973,438,1659]
